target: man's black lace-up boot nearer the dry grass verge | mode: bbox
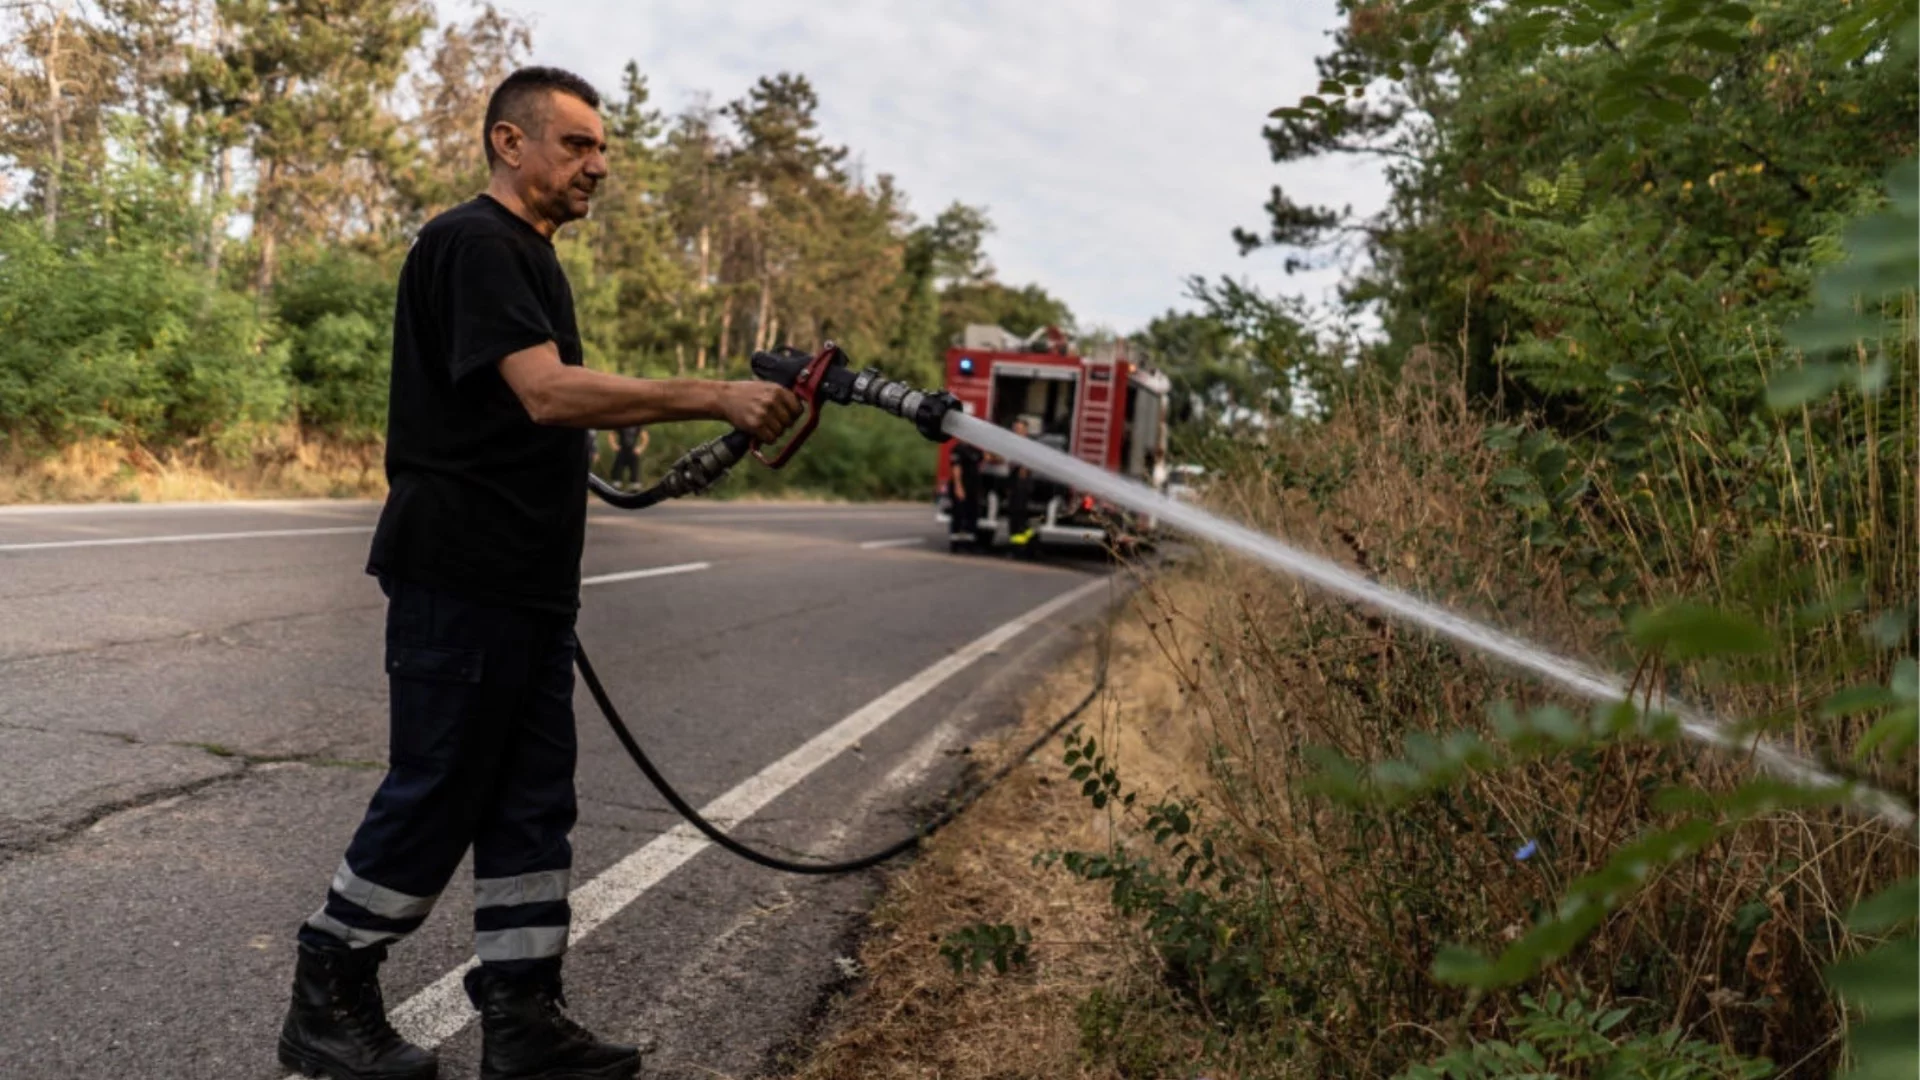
[467,967,639,1080]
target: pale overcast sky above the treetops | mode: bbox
[487,0,1384,332]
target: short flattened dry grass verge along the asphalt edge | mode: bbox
[793,595,1206,1080]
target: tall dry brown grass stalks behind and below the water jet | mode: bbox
[1105,359,1916,1076]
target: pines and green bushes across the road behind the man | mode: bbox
[0,0,1071,494]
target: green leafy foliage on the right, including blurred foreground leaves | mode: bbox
[1213,0,1920,1076]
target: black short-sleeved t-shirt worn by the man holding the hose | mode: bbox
[367,196,588,611]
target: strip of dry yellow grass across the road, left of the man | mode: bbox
[0,429,386,505]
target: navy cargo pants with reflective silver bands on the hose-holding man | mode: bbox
[300,578,576,976]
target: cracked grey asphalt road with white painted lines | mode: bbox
[0,502,1108,1080]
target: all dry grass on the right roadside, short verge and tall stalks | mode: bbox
[775,355,1916,1080]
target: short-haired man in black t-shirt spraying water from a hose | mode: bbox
[280,67,801,1080]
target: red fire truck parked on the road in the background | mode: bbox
[937,327,1169,550]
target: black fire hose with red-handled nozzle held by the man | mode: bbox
[574,342,1106,874]
